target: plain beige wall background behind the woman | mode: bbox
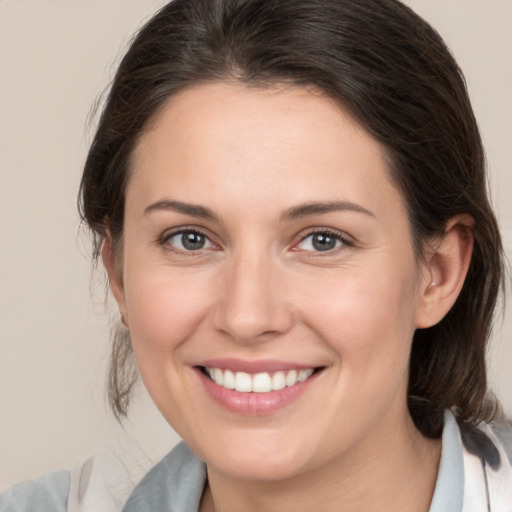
[0,0,512,488]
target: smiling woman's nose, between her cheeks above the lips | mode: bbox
[214,252,294,344]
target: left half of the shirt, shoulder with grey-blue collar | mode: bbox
[0,442,202,512]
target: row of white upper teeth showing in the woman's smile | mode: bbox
[206,368,314,393]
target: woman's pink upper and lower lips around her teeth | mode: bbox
[194,359,323,417]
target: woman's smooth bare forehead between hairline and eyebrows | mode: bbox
[127,83,401,220]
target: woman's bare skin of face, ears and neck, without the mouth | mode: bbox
[103,83,471,512]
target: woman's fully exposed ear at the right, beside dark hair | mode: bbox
[416,214,475,329]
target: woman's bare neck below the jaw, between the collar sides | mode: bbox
[200,415,441,512]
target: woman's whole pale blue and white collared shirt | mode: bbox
[0,411,512,512]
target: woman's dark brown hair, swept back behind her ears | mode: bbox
[80,0,503,437]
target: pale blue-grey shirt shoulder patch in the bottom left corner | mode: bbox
[0,471,71,512]
